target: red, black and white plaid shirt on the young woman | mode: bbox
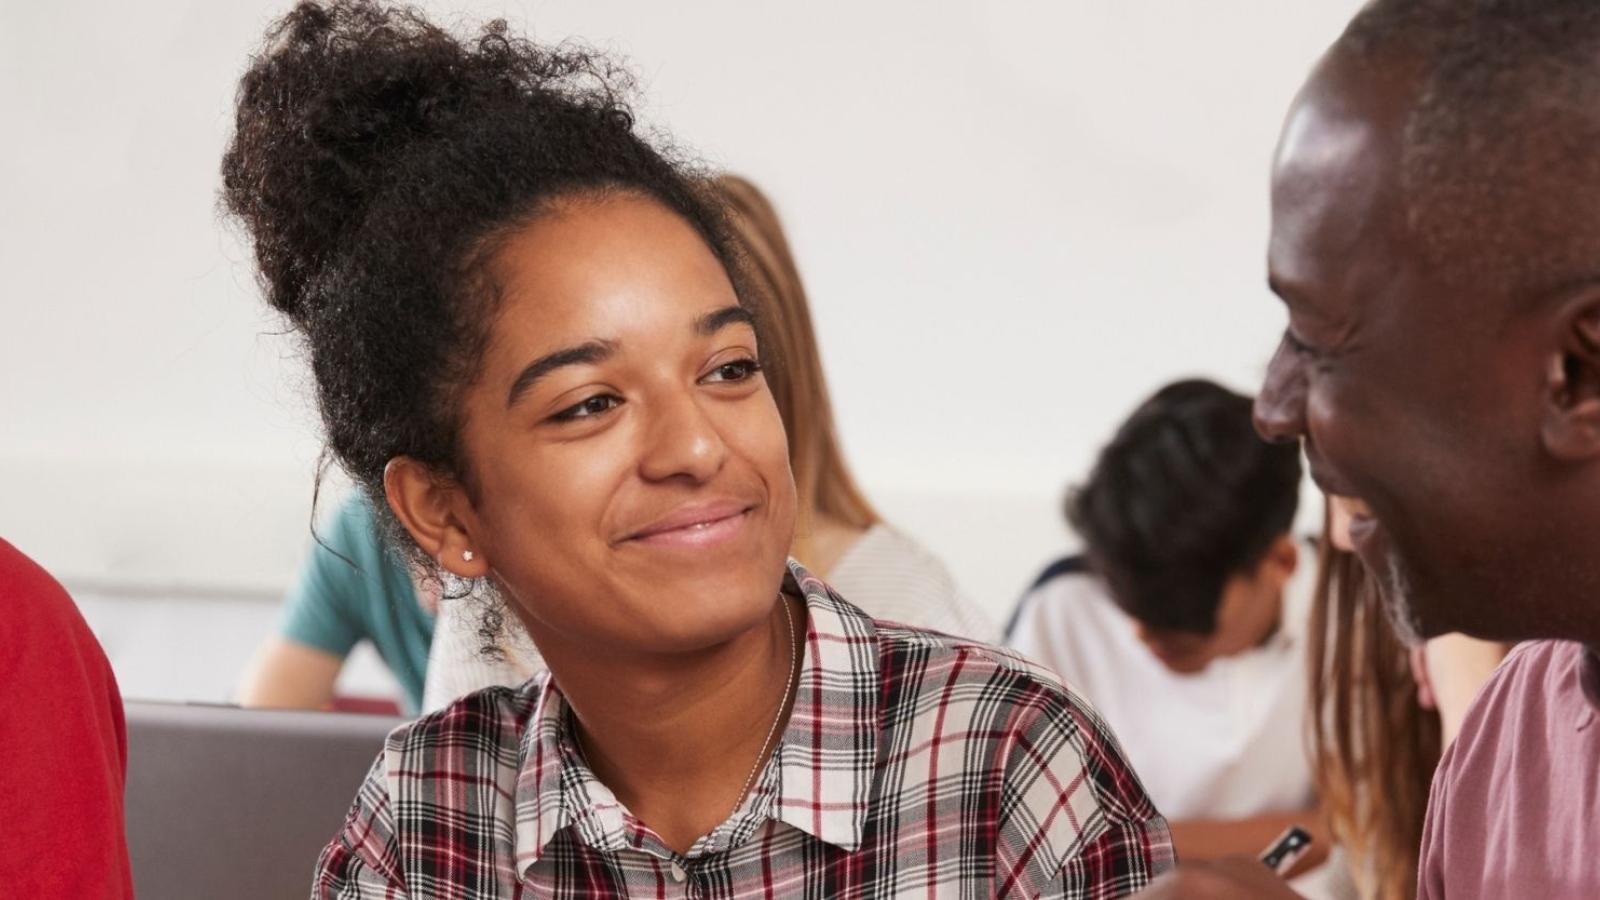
[314,562,1173,900]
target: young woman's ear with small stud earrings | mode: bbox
[384,456,490,578]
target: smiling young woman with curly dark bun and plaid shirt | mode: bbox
[222,2,1171,898]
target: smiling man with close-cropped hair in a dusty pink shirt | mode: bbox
[1147,0,1600,900]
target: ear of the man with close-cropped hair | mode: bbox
[1541,296,1600,463]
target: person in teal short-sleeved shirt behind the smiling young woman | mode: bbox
[238,493,438,713]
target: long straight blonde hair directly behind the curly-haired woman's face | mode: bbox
[714,175,882,560]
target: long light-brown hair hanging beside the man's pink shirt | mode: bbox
[1309,506,1440,900]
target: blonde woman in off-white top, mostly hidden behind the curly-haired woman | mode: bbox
[422,175,1000,709]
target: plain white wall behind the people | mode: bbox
[0,0,1357,693]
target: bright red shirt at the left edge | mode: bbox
[0,540,133,900]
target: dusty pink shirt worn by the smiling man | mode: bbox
[1418,641,1600,900]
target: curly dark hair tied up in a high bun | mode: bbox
[222,0,744,621]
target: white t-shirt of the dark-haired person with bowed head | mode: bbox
[1010,552,1317,820]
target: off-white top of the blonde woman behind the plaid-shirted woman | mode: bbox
[422,524,1000,713]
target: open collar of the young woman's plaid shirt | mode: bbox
[515,559,878,878]
